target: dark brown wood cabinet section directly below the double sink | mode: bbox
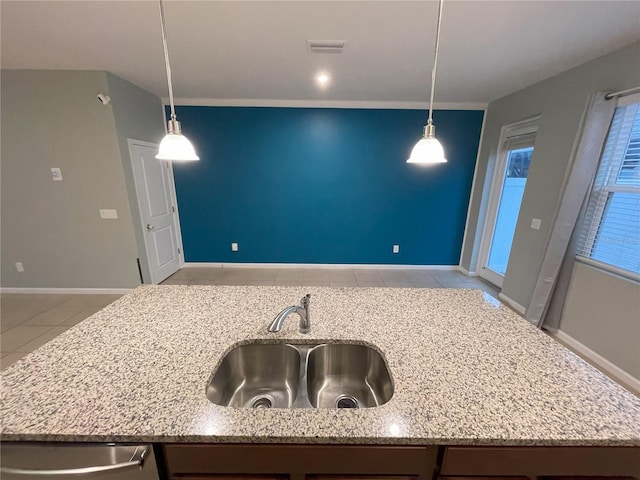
[163,444,438,480]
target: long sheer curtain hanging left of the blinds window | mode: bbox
[525,92,617,330]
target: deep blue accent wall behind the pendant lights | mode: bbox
[174,106,483,265]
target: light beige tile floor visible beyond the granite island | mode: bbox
[0,267,498,369]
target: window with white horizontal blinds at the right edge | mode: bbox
[578,96,640,277]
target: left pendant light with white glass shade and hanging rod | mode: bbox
[156,0,200,162]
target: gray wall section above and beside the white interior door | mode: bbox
[107,73,165,283]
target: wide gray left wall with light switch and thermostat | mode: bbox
[1,71,161,288]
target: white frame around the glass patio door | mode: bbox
[476,115,540,288]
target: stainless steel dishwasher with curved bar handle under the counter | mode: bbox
[0,442,158,480]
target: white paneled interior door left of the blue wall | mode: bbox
[129,141,180,284]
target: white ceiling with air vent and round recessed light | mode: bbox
[0,0,640,106]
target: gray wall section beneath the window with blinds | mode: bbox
[560,262,640,380]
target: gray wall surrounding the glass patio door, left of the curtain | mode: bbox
[460,43,640,308]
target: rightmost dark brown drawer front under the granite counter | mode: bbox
[441,447,640,478]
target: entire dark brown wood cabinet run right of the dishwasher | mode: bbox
[162,444,640,480]
